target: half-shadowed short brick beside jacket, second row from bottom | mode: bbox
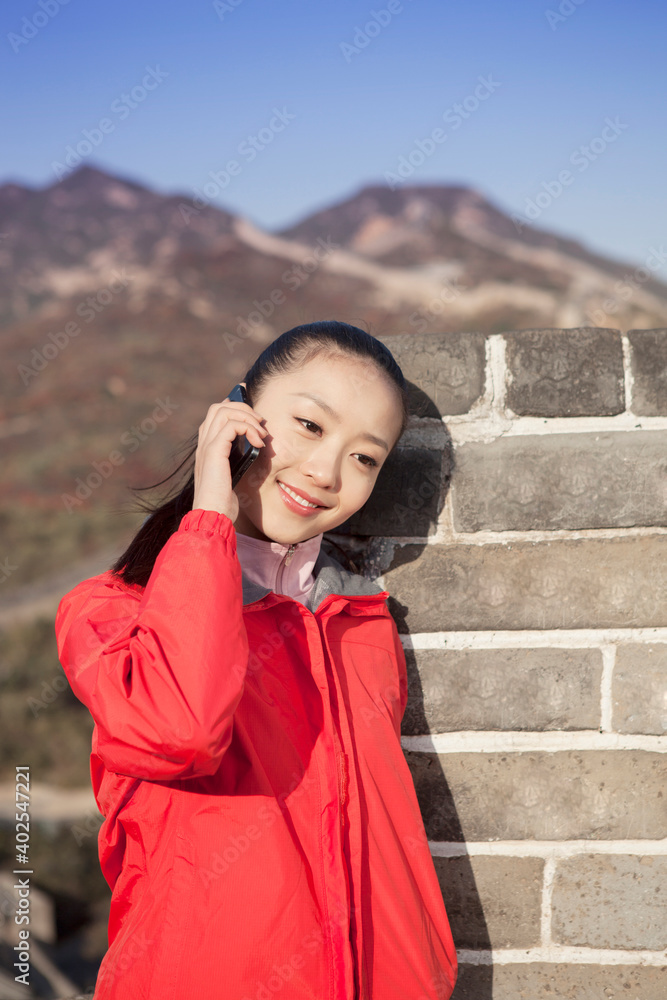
[433,855,544,950]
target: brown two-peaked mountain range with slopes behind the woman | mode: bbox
[0,166,667,594]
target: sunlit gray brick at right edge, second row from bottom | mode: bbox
[551,854,667,951]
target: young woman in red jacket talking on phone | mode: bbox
[56,322,457,1000]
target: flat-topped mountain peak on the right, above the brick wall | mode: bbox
[280,185,667,331]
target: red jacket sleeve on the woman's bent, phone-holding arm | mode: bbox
[55,510,248,780]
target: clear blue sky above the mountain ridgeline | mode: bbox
[0,0,667,270]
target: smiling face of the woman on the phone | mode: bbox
[234,355,402,545]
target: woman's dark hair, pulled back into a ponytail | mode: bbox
[111,320,409,587]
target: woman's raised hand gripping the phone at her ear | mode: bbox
[192,382,268,521]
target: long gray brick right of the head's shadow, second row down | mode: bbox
[452,430,667,531]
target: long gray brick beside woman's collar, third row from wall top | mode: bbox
[384,535,667,632]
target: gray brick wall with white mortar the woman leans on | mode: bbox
[341,327,667,1000]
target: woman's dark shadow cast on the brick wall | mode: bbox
[332,382,493,1000]
